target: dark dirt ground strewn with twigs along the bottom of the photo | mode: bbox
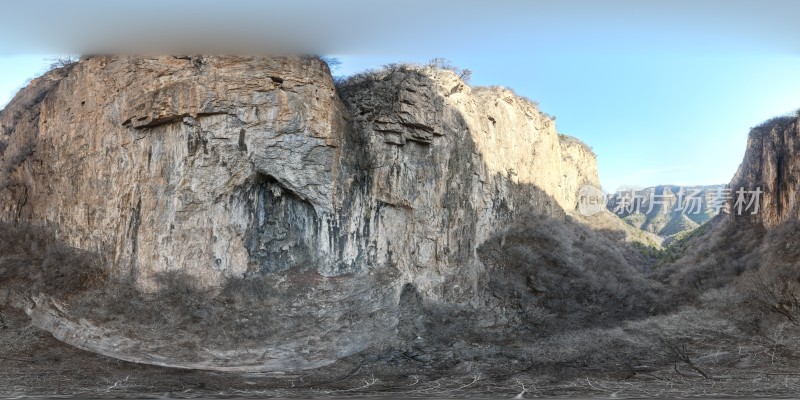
[0,309,800,398]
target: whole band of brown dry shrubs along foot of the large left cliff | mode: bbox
[0,220,332,346]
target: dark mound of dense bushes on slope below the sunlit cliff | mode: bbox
[479,215,663,331]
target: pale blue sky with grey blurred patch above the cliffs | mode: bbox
[0,0,800,190]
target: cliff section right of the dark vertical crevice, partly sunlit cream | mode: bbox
[340,67,596,301]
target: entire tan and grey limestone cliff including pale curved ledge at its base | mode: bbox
[0,56,596,370]
